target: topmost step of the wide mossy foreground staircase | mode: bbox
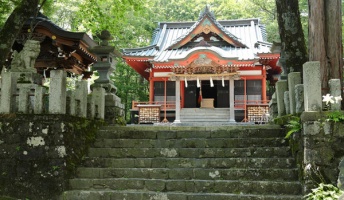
[98,125,285,139]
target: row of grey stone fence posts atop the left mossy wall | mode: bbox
[0,70,124,119]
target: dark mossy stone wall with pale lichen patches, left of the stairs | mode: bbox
[0,114,102,200]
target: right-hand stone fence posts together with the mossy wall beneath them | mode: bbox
[269,61,344,194]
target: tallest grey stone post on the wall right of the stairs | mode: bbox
[303,61,322,112]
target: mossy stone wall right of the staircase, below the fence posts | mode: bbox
[290,112,344,194]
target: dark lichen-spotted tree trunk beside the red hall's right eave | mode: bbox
[276,0,307,74]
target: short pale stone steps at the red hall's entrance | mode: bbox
[180,108,229,123]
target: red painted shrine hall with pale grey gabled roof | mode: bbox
[123,7,280,123]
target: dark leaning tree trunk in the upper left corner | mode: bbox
[0,0,39,71]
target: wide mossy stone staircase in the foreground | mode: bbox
[60,125,302,200]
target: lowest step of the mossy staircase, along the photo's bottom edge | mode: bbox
[59,190,302,200]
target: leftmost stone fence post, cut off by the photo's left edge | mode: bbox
[0,72,17,113]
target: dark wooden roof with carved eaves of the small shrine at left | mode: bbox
[12,13,98,78]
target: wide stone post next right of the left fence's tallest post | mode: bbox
[74,80,88,117]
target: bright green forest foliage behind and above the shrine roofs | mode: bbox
[0,0,308,121]
